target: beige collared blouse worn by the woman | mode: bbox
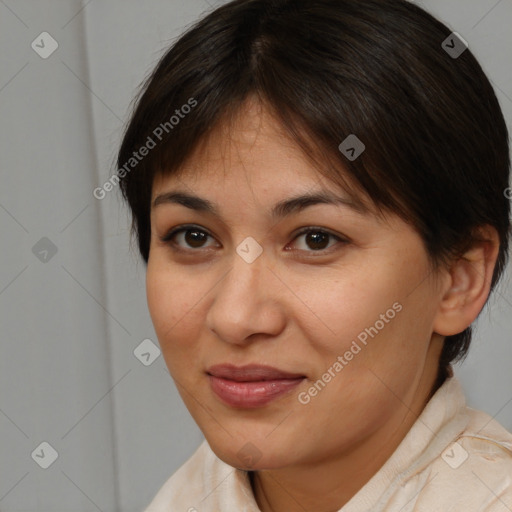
[145,377,512,512]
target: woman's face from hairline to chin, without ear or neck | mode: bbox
[147,102,446,470]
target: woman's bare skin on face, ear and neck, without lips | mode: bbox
[147,100,498,512]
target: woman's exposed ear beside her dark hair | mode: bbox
[433,225,500,336]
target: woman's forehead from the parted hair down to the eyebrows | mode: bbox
[152,97,375,217]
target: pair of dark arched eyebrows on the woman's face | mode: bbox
[152,190,368,219]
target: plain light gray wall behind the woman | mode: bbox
[0,0,512,512]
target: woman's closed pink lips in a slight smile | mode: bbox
[207,364,305,408]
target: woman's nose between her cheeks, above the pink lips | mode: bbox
[206,246,286,345]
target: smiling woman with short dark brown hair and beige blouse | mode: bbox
[118,0,512,512]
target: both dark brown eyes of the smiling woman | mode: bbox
[161,225,349,252]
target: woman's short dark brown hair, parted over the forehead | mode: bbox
[117,0,510,380]
